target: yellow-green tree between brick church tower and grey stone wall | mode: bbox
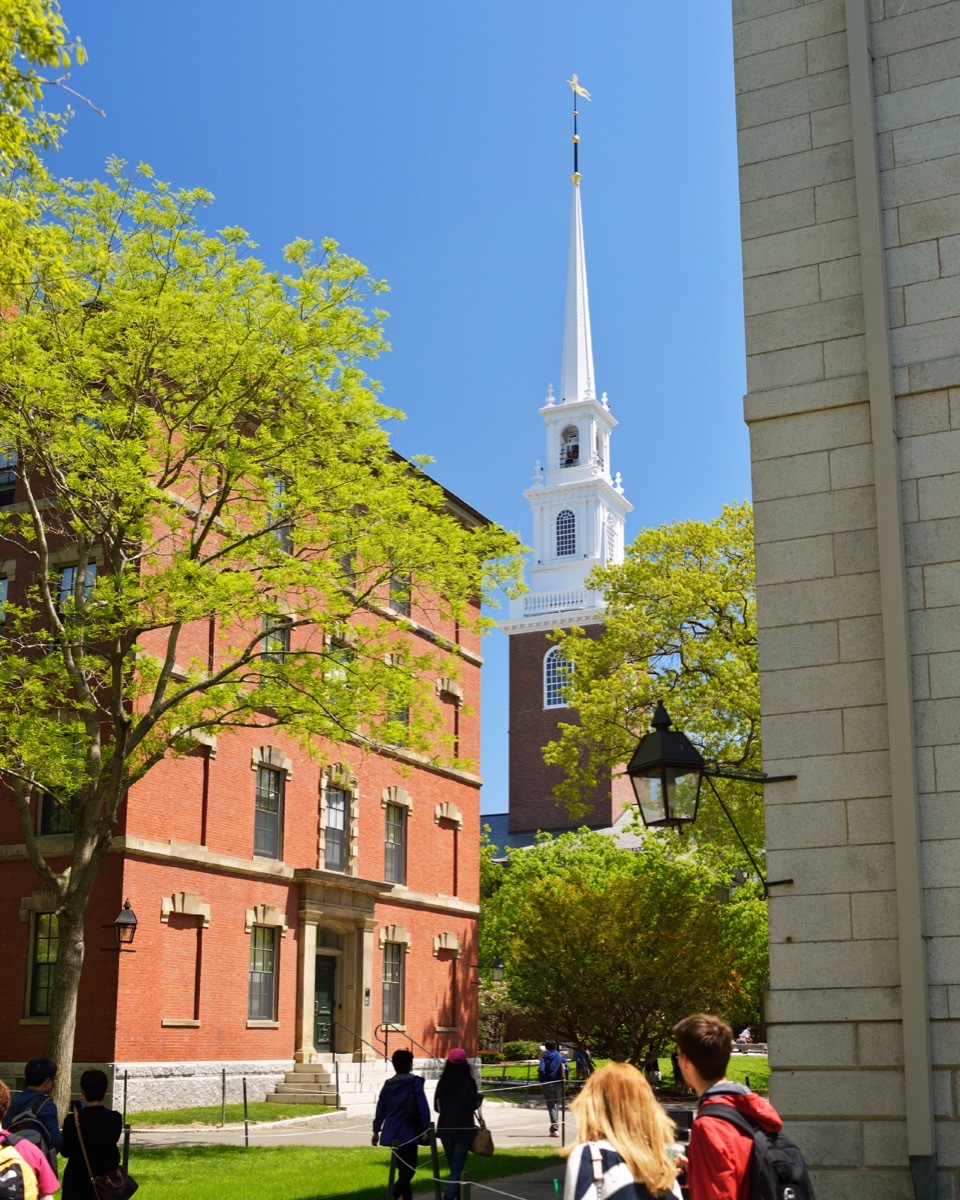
[544,503,763,856]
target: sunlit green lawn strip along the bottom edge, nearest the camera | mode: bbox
[130,1146,564,1200]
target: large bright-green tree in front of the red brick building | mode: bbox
[0,164,516,1108]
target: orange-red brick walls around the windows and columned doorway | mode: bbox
[0,595,480,1103]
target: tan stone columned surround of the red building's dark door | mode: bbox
[294,868,392,1062]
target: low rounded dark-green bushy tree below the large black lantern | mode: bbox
[481,829,767,1066]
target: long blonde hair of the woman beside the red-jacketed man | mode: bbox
[566,1062,677,1196]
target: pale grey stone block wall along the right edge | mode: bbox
[732,0,960,1200]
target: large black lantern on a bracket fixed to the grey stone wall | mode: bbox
[626,702,797,892]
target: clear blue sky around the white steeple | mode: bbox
[52,0,750,811]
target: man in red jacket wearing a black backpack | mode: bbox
[673,1013,814,1200]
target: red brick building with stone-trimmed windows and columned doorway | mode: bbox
[0,482,492,1109]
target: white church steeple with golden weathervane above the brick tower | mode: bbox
[502,76,632,634]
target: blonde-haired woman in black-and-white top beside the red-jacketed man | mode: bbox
[563,1062,680,1200]
